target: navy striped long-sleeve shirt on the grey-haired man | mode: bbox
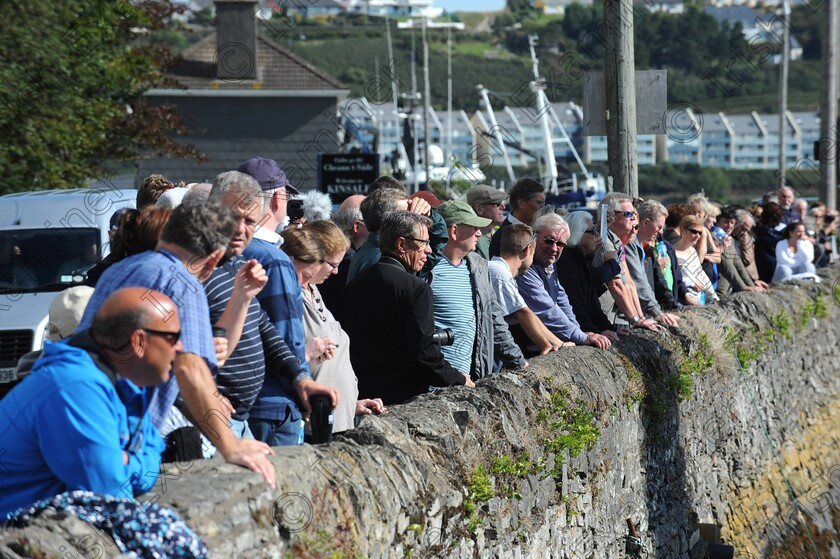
[204,256,309,421]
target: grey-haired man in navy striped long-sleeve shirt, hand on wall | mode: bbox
[204,171,338,444]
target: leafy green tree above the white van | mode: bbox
[0,0,201,193]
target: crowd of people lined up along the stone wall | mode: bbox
[0,163,836,552]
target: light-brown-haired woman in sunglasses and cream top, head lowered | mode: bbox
[281,221,387,433]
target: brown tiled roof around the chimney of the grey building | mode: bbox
[168,33,347,90]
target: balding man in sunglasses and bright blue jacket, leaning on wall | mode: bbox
[0,287,183,518]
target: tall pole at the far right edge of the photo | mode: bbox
[819,0,838,209]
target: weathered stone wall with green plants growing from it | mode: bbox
[0,270,840,559]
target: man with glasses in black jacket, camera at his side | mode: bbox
[341,211,474,405]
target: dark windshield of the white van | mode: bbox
[0,228,102,293]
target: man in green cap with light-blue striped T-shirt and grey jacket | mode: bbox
[432,200,528,380]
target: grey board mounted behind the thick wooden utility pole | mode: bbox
[583,70,668,136]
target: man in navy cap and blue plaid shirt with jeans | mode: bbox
[237,157,309,446]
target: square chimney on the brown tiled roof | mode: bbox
[215,0,259,81]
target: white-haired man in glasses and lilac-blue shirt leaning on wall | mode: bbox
[516,213,612,349]
